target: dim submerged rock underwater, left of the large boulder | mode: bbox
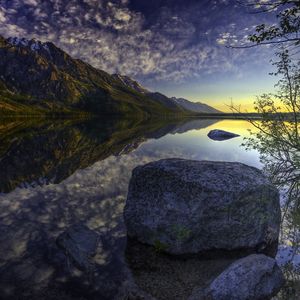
[56,224,99,271]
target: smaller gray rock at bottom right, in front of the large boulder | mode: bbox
[189,254,284,300]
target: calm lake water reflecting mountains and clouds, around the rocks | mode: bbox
[0,118,300,299]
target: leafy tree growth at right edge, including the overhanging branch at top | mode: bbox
[237,0,300,197]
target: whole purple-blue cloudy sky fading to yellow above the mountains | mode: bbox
[0,0,276,111]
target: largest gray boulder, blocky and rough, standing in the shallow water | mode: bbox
[124,159,280,255]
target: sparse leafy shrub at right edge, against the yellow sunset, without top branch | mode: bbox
[241,51,300,191]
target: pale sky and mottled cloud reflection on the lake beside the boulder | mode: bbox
[0,121,259,299]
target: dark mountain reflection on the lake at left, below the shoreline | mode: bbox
[0,119,217,192]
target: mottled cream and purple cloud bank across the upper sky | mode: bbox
[0,0,276,82]
